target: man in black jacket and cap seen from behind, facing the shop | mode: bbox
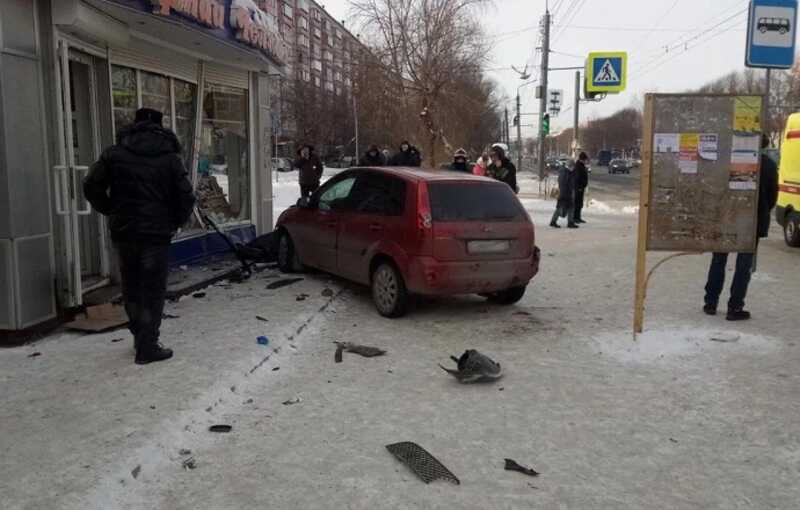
[83,108,195,365]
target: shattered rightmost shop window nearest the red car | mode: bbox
[197,84,250,223]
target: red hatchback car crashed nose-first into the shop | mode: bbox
[276,167,539,317]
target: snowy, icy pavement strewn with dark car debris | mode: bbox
[0,169,800,509]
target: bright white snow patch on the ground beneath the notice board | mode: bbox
[593,327,779,364]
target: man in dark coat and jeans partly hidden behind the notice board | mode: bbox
[703,135,778,321]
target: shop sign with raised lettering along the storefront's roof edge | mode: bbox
[110,0,288,63]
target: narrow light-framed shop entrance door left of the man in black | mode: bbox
[53,40,110,307]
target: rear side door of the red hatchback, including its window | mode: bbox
[337,172,406,283]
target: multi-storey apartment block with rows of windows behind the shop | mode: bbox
[257,0,364,156]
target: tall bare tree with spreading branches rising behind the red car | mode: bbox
[352,0,488,166]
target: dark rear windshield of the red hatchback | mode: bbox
[428,182,525,222]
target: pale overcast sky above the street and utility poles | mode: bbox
[323,0,792,136]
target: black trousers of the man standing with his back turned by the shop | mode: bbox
[114,242,169,351]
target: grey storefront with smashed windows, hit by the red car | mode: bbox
[0,0,287,331]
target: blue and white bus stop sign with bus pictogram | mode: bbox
[745,0,797,69]
